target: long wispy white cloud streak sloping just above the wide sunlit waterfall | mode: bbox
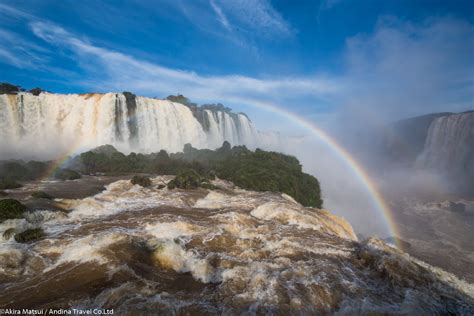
[31,22,338,108]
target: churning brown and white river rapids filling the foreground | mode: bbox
[0,176,474,315]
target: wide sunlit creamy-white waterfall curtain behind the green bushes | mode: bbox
[0,93,258,159]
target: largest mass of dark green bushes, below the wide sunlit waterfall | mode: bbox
[74,142,323,208]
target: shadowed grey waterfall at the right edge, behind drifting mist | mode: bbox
[417,112,474,190]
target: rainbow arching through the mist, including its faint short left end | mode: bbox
[42,97,402,249]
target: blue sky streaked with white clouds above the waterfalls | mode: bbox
[0,0,474,129]
